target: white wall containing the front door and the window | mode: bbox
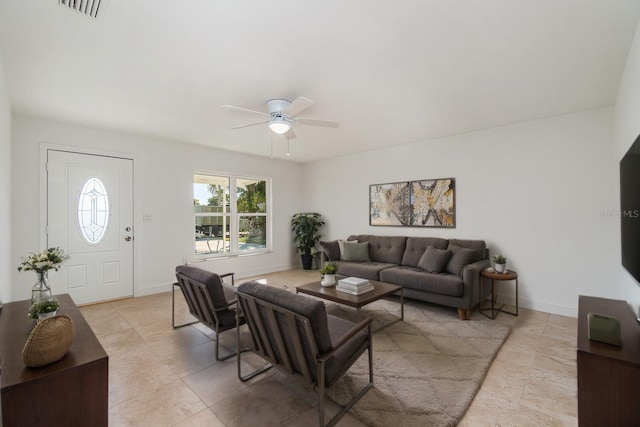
[11,115,302,300]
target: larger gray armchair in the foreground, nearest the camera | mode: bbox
[236,282,373,426]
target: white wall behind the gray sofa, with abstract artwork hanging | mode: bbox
[304,108,624,316]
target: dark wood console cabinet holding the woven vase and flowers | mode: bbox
[0,294,109,427]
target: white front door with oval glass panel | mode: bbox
[47,150,133,304]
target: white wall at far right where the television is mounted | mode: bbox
[613,23,640,312]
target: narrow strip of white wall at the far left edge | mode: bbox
[0,50,11,301]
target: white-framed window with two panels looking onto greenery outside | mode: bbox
[193,174,271,255]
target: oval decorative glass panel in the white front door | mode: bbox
[77,176,109,245]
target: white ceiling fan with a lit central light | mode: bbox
[222,96,340,139]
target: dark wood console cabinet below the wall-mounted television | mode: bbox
[577,295,640,426]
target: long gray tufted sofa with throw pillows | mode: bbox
[320,235,490,320]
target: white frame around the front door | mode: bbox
[39,142,141,297]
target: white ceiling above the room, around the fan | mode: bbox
[0,0,640,162]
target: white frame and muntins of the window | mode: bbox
[191,171,273,260]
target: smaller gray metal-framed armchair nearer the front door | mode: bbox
[173,265,244,360]
